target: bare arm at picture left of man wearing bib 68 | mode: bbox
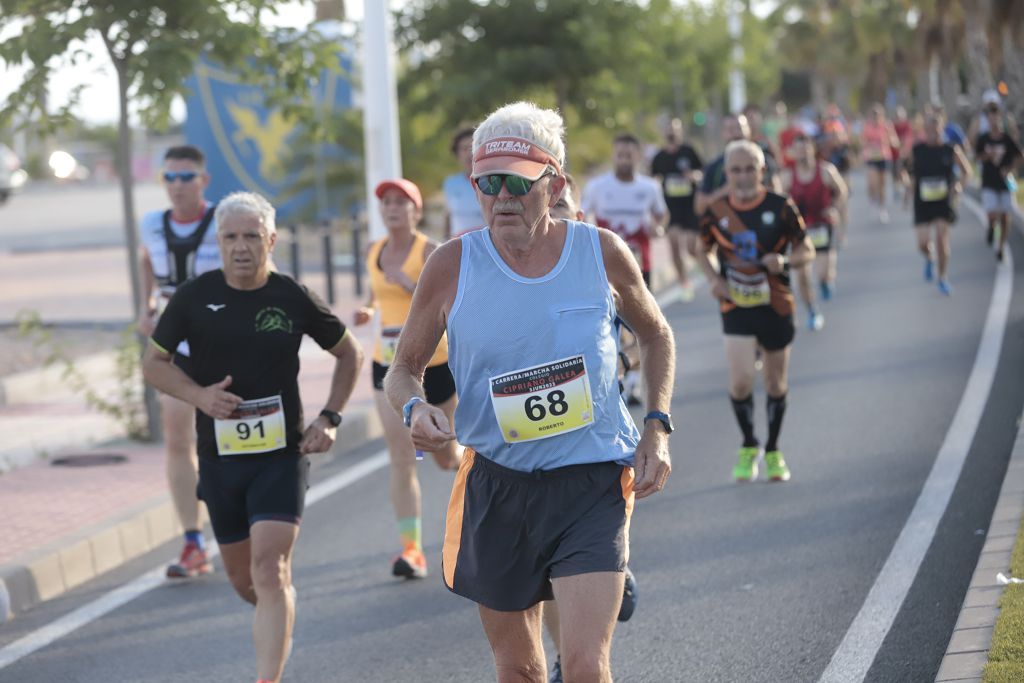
[384,240,462,451]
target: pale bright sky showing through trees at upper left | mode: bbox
[0,0,385,125]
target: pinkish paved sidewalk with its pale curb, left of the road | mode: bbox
[0,232,674,623]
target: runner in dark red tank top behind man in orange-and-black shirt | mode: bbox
[783,135,847,330]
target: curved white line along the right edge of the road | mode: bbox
[821,197,1014,683]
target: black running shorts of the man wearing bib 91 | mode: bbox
[197,455,309,544]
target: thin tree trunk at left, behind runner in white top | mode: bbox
[111,58,163,441]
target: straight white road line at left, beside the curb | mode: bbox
[0,451,388,670]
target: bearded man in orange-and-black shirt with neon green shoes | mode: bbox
[700,140,814,481]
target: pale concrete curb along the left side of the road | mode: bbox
[0,405,384,624]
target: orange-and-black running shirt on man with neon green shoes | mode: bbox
[700,190,807,315]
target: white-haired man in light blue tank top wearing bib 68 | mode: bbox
[384,102,675,682]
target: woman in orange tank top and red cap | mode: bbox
[355,178,460,579]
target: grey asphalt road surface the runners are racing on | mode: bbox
[0,187,1024,683]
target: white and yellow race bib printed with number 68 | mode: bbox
[489,355,594,443]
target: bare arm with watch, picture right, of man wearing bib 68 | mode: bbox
[600,230,676,498]
